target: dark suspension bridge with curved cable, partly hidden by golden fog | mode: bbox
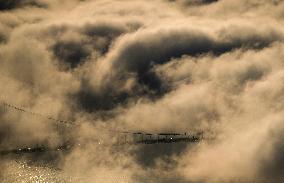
[0,101,204,156]
